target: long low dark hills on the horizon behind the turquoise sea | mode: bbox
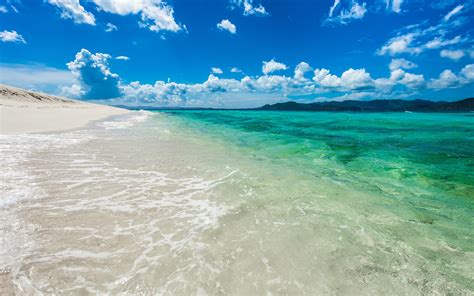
[253,98,474,112]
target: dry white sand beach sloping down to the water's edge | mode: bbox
[0,84,130,135]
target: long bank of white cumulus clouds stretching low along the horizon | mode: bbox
[52,49,474,107]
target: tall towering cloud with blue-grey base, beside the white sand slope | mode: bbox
[67,49,121,99]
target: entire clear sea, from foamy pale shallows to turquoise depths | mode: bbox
[0,111,474,295]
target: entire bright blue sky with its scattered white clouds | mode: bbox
[0,0,474,108]
